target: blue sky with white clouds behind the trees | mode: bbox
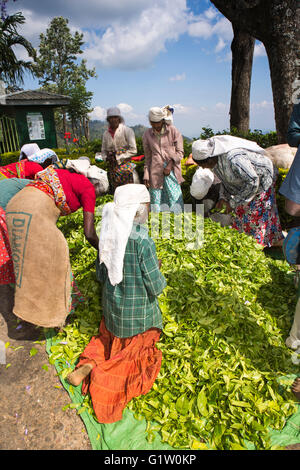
[9,0,275,137]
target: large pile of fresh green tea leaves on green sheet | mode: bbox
[50,202,299,449]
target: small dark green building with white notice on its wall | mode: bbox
[0,90,70,154]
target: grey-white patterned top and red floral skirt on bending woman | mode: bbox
[213,149,284,247]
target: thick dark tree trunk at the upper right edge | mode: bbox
[211,0,300,143]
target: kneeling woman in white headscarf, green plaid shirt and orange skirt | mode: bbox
[68,184,166,423]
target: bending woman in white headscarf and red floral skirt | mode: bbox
[192,135,284,247]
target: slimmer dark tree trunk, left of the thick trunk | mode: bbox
[229,23,255,133]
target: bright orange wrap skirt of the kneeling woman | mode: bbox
[76,318,162,423]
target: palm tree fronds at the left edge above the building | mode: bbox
[0,12,36,85]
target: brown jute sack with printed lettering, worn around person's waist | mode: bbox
[6,186,71,327]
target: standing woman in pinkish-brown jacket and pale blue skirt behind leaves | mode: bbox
[143,106,184,213]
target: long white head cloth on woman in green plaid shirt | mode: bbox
[99,184,150,286]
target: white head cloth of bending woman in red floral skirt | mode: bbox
[192,135,265,161]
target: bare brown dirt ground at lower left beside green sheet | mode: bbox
[0,286,300,450]
